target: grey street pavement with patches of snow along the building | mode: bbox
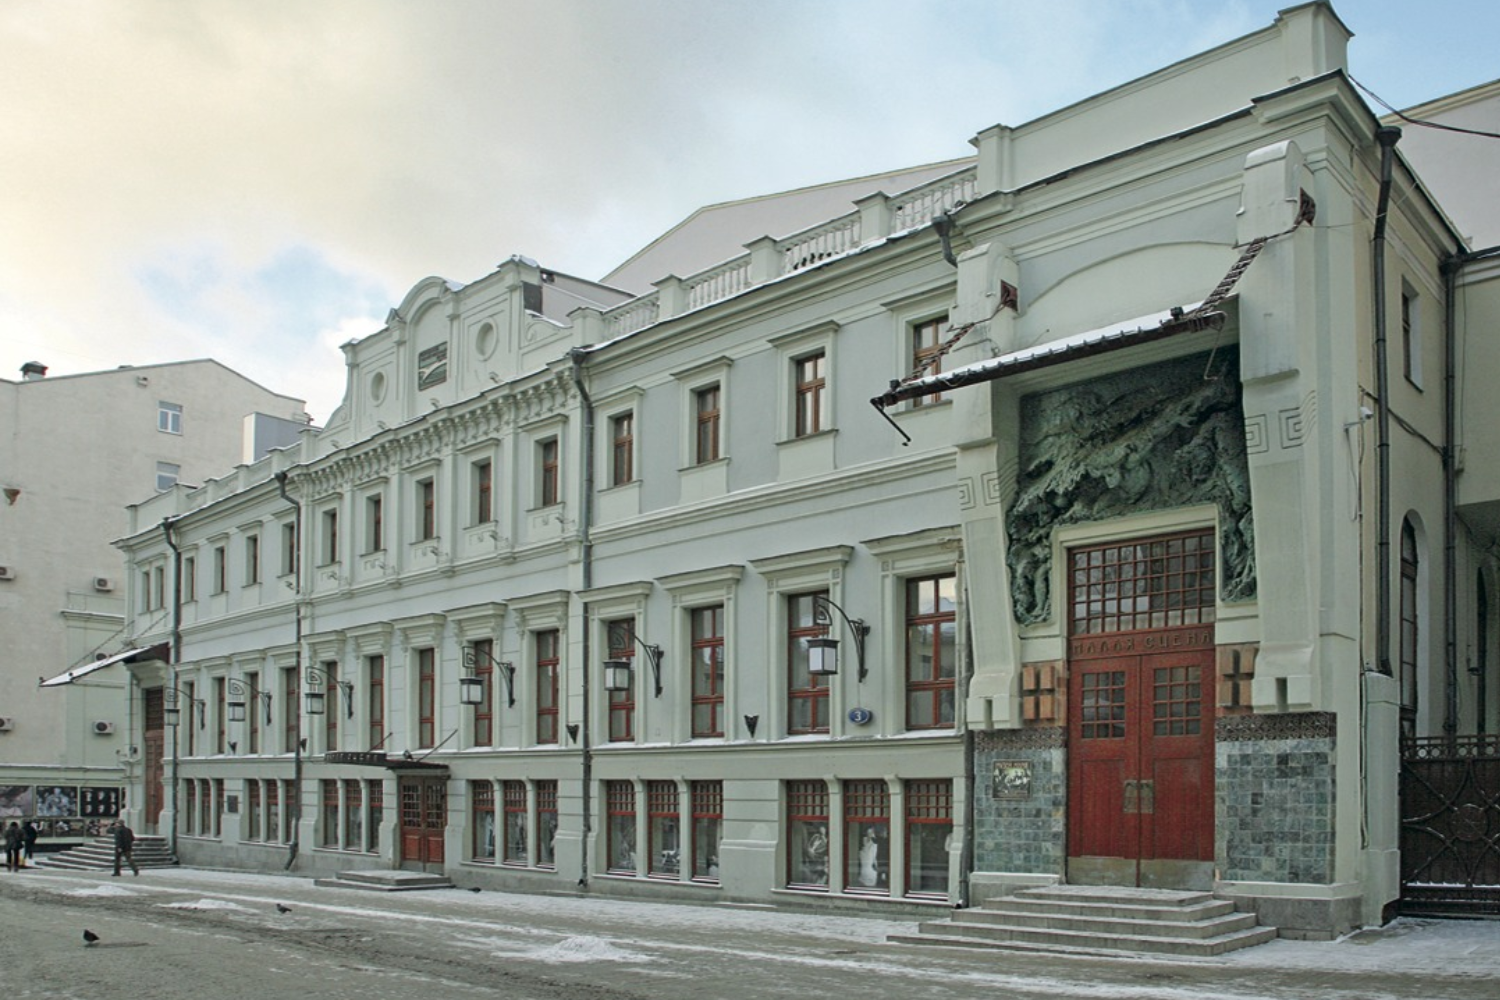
[0,868,1500,1000]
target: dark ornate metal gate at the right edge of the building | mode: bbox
[1401,735,1500,916]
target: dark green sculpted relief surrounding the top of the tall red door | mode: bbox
[1005,349,1256,625]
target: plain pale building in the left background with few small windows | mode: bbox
[0,360,308,840]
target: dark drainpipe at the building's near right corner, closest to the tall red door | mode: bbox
[1371,126,1401,676]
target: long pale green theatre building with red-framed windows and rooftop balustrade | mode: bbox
[122,3,1500,936]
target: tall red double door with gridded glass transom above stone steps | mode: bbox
[1068,531,1215,889]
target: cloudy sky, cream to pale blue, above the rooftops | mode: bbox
[0,0,1500,423]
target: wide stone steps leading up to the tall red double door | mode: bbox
[888,886,1277,958]
